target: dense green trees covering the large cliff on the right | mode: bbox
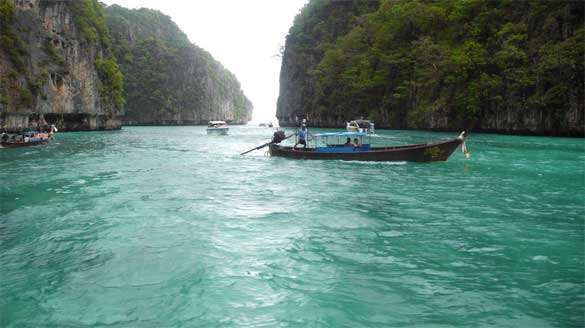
[278,0,585,135]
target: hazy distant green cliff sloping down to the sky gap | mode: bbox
[105,5,252,125]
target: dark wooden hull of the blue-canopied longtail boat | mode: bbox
[269,138,462,162]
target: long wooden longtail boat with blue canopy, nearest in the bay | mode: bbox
[267,131,468,162]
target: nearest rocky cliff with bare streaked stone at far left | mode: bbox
[0,0,123,131]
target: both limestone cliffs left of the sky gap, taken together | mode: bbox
[0,0,252,132]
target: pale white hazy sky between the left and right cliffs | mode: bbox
[102,0,308,121]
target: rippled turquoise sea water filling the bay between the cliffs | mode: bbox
[0,127,585,327]
